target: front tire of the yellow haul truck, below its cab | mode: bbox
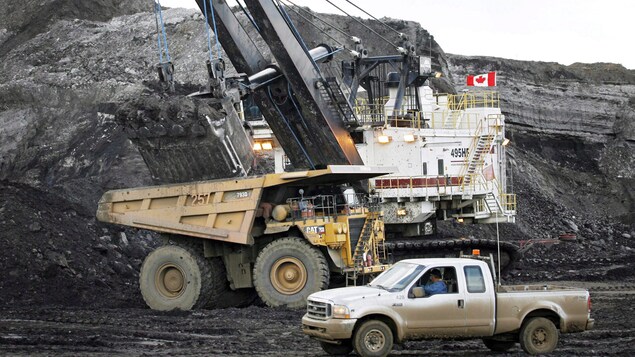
[254,237,329,308]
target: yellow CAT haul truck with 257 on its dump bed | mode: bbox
[97,165,390,310]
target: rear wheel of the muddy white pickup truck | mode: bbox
[519,317,558,355]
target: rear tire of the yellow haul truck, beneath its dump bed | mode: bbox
[139,245,219,311]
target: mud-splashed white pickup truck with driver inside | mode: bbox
[302,258,594,356]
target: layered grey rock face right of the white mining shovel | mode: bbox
[449,55,635,236]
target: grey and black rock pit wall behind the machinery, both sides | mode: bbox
[0,0,635,305]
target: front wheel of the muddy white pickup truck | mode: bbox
[353,320,393,357]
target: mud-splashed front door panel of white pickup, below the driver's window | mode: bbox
[400,266,466,338]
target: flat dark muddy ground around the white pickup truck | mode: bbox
[0,282,635,356]
